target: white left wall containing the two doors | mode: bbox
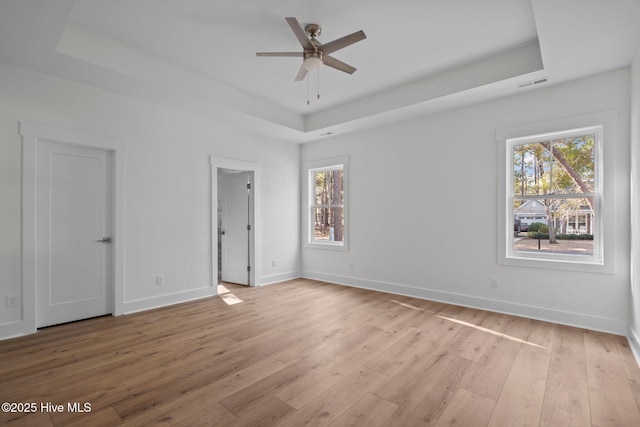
[0,63,300,338]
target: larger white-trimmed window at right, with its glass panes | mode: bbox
[497,113,615,272]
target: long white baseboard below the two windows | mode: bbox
[302,270,629,336]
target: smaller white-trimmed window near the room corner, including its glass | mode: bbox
[306,158,347,250]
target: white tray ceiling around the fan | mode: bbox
[0,0,640,142]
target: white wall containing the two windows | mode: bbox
[301,70,630,334]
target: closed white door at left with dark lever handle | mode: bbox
[36,142,113,327]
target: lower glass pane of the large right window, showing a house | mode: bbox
[513,198,596,256]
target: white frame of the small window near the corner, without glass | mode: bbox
[304,156,349,251]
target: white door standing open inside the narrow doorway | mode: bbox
[221,172,252,285]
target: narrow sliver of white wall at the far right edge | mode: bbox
[629,50,640,361]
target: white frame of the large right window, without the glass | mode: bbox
[496,111,617,274]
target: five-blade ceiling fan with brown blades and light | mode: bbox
[256,17,367,81]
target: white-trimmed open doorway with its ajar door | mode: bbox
[211,156,259,289]
